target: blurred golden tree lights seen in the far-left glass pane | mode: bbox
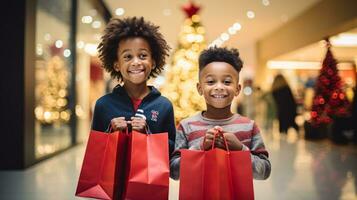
[35,46,71,124]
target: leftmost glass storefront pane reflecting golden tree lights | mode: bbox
[34,0,74,158]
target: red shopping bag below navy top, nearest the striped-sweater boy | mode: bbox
[123,131,170,200]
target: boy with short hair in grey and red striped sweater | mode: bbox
[170,47,271,179]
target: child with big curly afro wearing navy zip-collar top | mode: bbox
[92,17,176,155]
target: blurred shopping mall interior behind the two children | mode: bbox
[0,0,357,200]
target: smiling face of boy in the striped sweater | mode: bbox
[197,62,241,109]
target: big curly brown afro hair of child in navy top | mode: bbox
[98,17,170,81]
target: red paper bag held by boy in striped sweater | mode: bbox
[179,132,254,200]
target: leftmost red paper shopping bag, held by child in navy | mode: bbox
[76,130,128,199]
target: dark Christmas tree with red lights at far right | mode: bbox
[310,39,349,127]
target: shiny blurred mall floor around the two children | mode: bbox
[0,127,357,200]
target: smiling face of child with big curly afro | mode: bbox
[114,37,154,84]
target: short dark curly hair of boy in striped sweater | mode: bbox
[198,46,243,73]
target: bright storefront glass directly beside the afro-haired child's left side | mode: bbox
[76,1,106,142]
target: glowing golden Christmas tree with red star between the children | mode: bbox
[161,2,206,123]
